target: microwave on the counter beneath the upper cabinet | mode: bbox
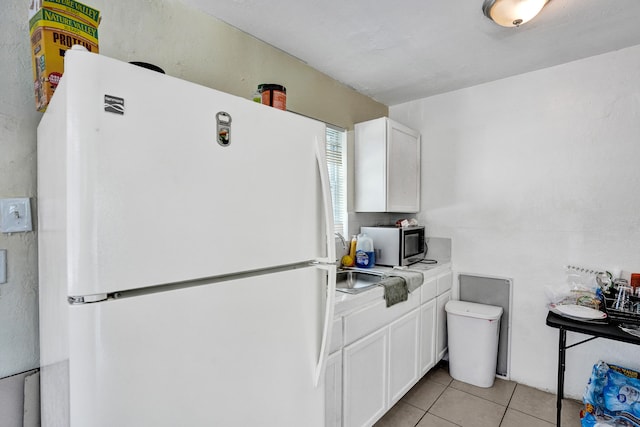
[360,225,427,267]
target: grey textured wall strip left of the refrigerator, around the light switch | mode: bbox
[0,0,40,378]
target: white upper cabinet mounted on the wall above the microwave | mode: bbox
[355,117,420,213]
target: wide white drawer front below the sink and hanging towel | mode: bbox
[344,292,420,345]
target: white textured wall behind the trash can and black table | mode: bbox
[390,46,640,397]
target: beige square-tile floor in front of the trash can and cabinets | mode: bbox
[375,365,581,427]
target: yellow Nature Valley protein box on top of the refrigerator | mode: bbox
[29,0,100,111]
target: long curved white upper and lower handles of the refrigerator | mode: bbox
[315,137,336,387]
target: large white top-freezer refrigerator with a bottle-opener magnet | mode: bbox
[38,48,335,427]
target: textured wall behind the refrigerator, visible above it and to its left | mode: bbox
[0,0,388,386]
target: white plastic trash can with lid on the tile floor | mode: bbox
[445,301,502,388]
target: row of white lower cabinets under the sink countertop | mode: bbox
[325,269,453,427]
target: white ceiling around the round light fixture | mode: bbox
[182,0,640,105]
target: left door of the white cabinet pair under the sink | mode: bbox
[343,328,389,427]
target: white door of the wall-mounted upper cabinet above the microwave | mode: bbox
[387,120,420,212]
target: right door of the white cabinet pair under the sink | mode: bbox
[389,309,420,406]
